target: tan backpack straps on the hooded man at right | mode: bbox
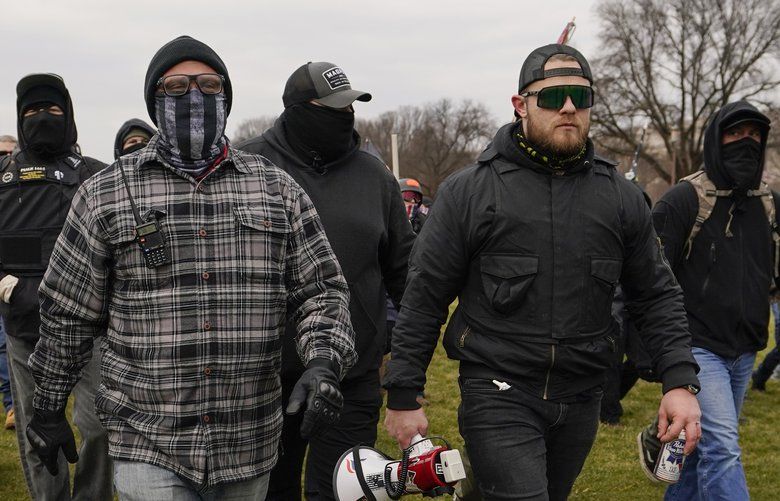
[680,170,780,278]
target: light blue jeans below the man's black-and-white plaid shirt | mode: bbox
[114,460,270,501]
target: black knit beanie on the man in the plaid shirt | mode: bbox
[144,35,233,125]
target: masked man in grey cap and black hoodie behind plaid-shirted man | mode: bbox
[238,62,414,501]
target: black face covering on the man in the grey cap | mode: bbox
[284,103,355,165]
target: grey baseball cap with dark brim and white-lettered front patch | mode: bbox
[282,61,371,108]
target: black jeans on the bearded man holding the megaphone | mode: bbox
[458,378,601,501]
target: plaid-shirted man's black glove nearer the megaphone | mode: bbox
[285,358,344,439]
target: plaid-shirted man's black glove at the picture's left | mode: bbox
[27,409,79,475]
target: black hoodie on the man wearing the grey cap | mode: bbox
[238,115,414,380]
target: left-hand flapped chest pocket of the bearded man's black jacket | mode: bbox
[480,254,539,318]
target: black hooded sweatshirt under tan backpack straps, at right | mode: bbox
[653,101,780,358]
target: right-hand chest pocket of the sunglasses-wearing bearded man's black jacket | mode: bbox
[580,257,623,333]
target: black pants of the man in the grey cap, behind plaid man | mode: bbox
[266,371,382,501]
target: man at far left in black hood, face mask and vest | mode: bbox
[0,73,113,500]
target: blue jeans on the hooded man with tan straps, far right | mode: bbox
[664,348,756,501]
